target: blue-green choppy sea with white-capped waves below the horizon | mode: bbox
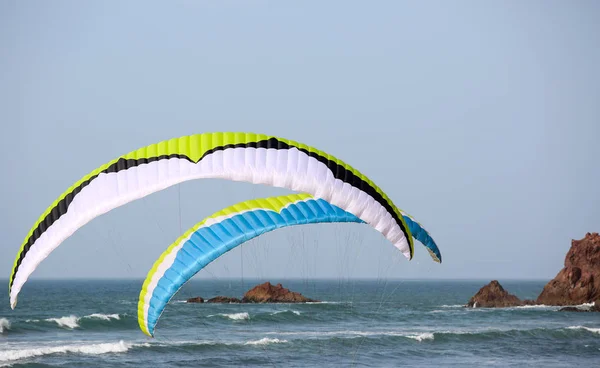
[0,279,600,367]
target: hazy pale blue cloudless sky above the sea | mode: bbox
[0,0,600,279]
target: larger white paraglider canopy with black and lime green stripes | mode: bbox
[9,133,414,308]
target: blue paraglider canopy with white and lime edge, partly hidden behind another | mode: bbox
[138,194,441,336]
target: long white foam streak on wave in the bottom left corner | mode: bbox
[0,340,148,362]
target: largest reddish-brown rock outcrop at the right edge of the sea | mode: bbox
[537,233,600,305]
